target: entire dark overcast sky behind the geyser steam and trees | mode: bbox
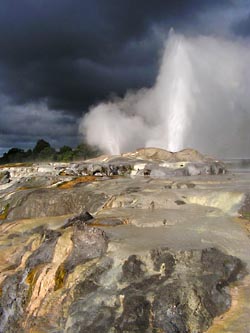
[0,0,250,154]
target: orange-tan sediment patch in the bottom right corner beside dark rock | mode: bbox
[206,275,250,333]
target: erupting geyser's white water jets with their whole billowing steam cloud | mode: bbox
[80,32,250,157]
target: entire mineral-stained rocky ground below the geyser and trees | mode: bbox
[0,148,250,333]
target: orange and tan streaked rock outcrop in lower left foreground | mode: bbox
[0,225,108,333]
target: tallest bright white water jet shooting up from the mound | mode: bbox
[146,31,195,151]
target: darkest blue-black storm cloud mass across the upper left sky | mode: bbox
[0,0,232,112]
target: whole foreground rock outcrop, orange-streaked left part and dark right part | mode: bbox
[0,225,245,333]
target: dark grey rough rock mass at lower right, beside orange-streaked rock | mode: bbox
[64,248,244,333]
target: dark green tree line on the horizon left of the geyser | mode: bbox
[0,139,100,164]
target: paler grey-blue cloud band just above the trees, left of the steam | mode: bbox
[0,96,78,150]
